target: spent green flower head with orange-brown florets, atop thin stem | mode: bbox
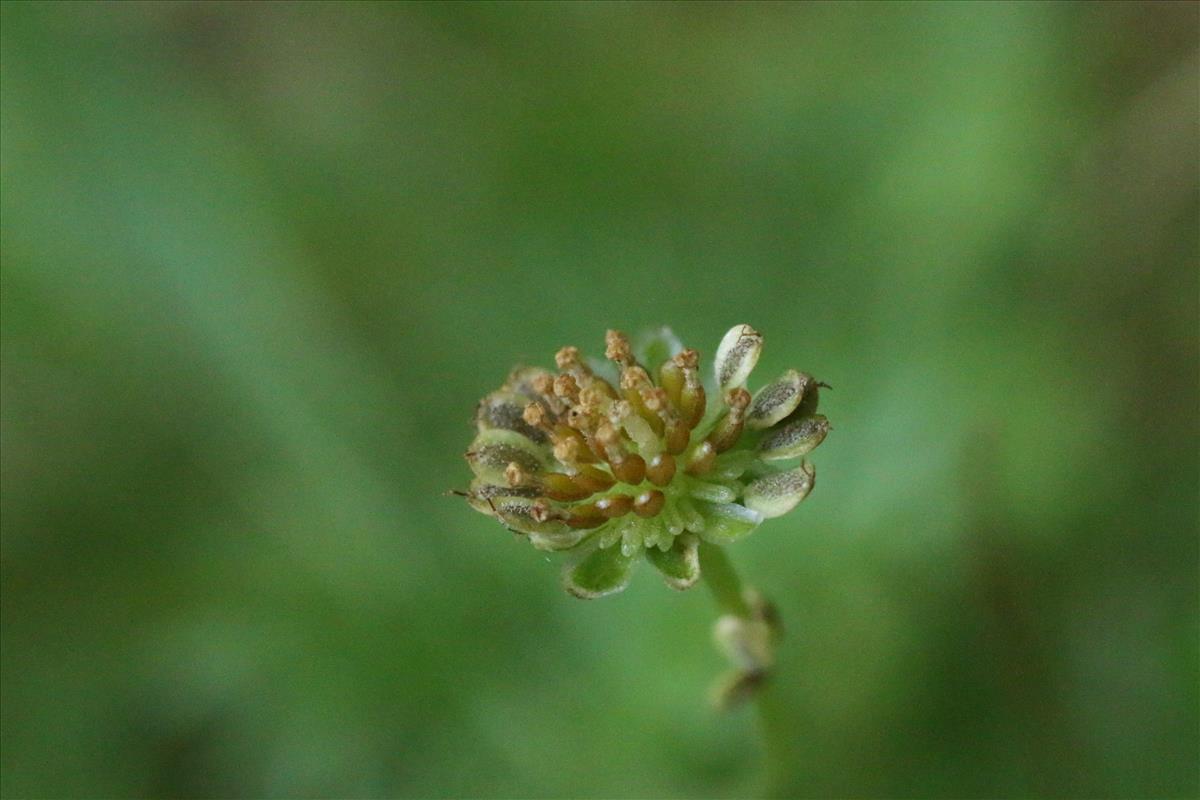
[463,325,829,597]
